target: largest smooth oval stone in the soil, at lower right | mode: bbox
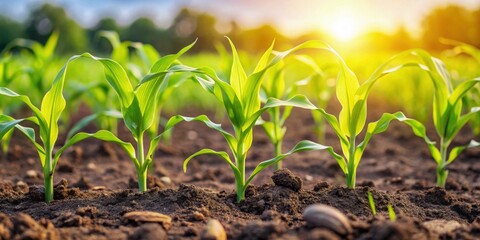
[302,204,352,236]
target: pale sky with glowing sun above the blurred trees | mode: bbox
[0,0,480,38]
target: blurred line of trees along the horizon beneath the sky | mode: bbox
[0,4,480,54]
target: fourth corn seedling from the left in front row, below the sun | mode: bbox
[317,50,425,188]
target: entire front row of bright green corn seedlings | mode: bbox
[0,33,480,202]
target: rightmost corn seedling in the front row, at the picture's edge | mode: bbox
[394,50,480,187]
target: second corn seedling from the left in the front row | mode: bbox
[65,40,193,192]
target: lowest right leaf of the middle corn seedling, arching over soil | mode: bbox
[243,140,346,190]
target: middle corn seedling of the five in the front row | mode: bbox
[167,40,340,202]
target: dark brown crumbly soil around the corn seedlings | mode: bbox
[0,110,480,239]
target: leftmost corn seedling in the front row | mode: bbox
[0,54,95,202]
